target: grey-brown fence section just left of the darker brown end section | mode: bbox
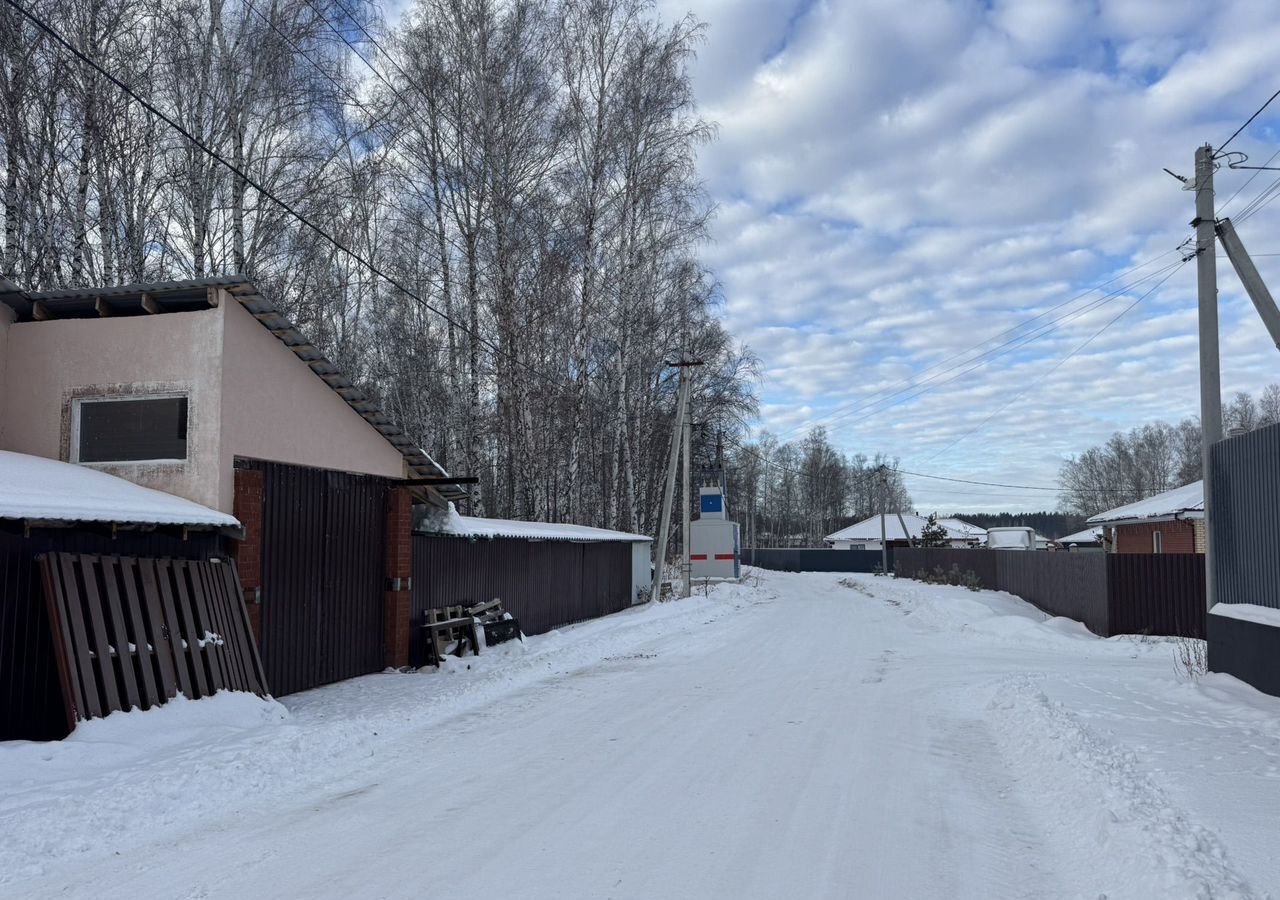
[991,550,1111,638]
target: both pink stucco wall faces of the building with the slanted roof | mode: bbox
[0,293,404,512]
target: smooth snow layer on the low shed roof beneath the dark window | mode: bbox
[0,451,239,529]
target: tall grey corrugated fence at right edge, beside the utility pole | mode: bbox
[1210,425,1280,609]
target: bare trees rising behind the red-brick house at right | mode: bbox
[1059,384,1280,516]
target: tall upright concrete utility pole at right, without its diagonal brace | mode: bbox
[1192,143,1222,609]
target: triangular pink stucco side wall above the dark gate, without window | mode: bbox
[219,294,404,510]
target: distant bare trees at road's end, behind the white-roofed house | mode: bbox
[727,428,911,547]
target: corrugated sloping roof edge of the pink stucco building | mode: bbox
[0,275,467,499]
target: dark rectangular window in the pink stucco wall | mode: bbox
[77,397,187,462]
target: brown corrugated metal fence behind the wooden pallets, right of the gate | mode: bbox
[410,534,632,664]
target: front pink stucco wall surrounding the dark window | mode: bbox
[0,310,223,506]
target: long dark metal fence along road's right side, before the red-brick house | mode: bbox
[895,549,1206,638]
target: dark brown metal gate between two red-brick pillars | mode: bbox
[237,461,388,696]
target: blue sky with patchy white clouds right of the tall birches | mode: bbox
[384,0,1280,511]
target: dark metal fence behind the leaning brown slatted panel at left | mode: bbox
[0,524,224,740]
